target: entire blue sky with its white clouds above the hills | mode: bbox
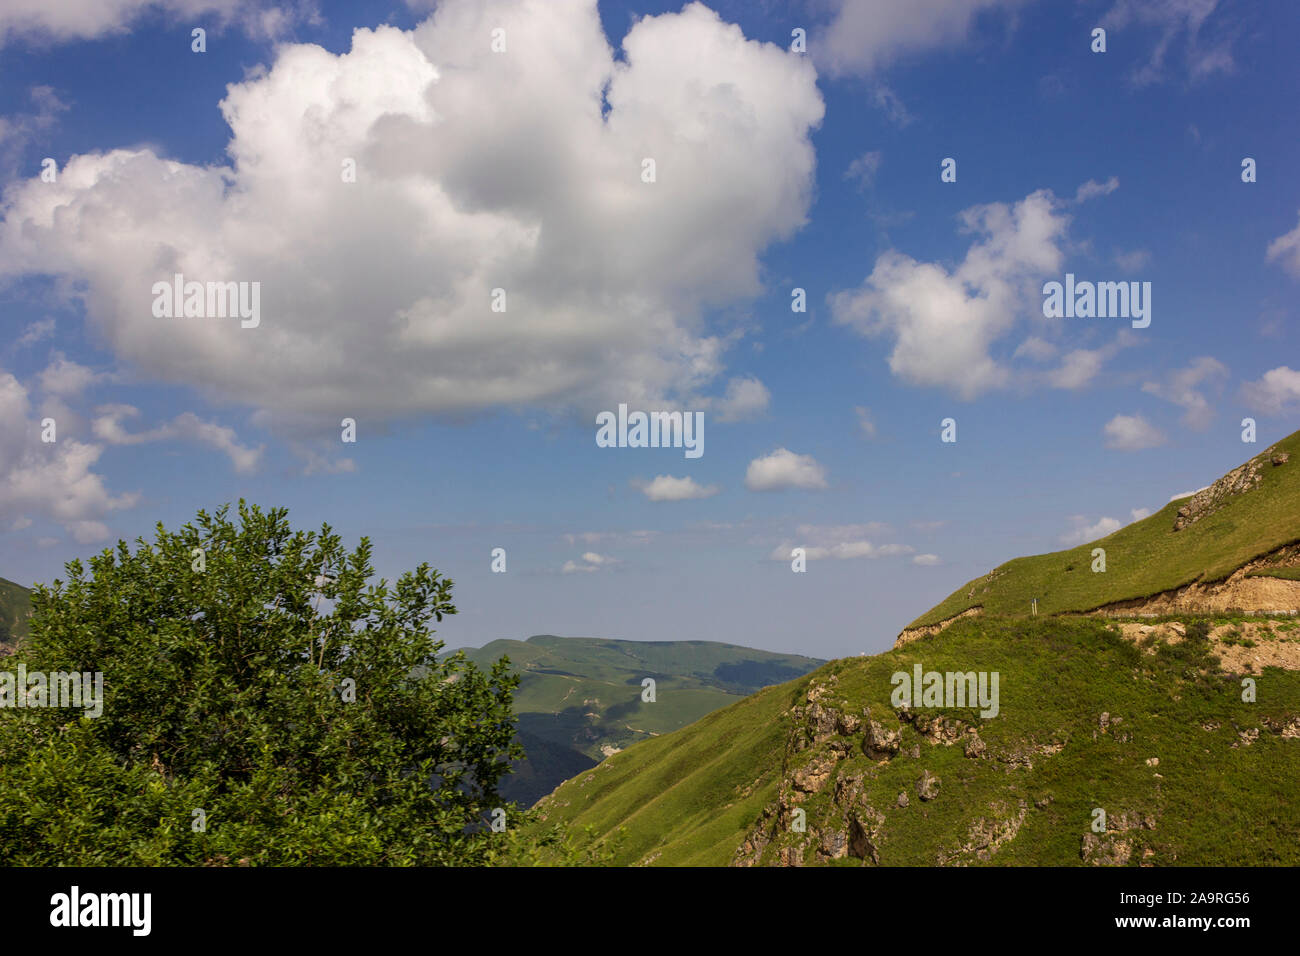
[0,0,1300,657]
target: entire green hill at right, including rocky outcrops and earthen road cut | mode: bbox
[527,436,1300,866]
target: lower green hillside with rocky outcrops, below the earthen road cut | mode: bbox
[538,618,1300,866]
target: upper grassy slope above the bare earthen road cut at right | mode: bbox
[909,432,1300,627]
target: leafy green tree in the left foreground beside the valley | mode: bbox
[0,501,523,865]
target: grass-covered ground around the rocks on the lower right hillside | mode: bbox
[541,618,1300,865]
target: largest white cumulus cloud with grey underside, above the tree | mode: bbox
[0,0,824,432]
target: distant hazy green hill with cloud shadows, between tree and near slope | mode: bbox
[452,635,824,805]
